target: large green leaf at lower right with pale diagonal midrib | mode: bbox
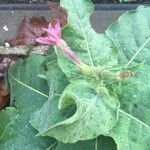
[111,69,150,150]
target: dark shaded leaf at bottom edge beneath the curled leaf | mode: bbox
[56,136,117,150]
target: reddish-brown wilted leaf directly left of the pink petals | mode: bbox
[9,17,48,46]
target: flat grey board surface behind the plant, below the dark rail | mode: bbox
[0,10,124,44]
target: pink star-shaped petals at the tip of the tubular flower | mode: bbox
[36,21,61,45]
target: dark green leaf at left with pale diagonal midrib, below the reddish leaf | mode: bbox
[8,55,49,114]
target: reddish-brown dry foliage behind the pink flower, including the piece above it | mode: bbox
[8,1,67,46]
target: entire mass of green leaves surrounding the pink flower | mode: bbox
[0,0,150,150]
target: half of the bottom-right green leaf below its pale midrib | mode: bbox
[110,110,150,150]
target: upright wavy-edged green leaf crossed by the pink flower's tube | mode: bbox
[57,0,117,80]
